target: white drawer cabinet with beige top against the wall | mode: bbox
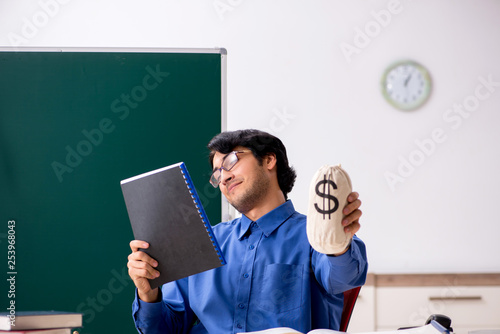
[348,273,500,334]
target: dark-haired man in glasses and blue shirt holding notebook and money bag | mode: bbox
[128,130,367,334]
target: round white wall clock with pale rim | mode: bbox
[382,61,431,110]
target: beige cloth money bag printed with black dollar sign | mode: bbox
[307,165,352,254]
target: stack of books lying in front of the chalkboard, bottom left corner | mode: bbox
[0,311,82,334]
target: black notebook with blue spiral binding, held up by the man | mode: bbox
[120,162,226,288]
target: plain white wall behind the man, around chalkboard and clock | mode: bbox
[0,0,500,273]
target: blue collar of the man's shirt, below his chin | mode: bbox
[238,200,295,240]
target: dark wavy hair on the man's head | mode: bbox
[208,129,297,198]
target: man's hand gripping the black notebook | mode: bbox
[127,240,160,303]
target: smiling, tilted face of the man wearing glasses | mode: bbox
[213,146,269,213]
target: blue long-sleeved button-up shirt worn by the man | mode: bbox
[132,201,367,334]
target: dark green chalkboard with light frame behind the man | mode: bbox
[0,49,226,334]
